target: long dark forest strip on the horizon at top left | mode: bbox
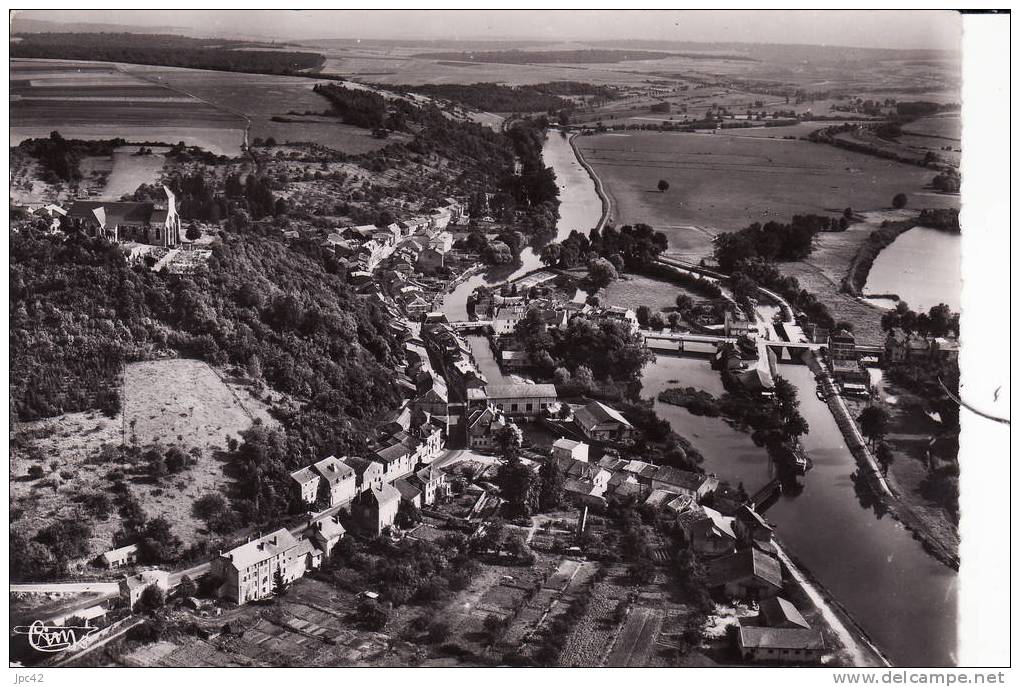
[10,34,325,74]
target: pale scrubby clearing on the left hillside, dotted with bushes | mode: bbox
[10,360,274,557]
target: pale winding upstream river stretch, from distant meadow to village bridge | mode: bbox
[442,131,602,321]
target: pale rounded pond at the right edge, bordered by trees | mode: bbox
[864,226,963,312]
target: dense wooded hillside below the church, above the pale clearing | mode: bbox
[10,233,396,420]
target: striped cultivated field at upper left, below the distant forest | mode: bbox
[10,60,245,154]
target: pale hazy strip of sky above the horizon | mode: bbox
[14,9,961,49]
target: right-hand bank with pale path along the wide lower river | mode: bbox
[808,352,960,570]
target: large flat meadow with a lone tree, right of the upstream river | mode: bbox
[576,133,955,258]
